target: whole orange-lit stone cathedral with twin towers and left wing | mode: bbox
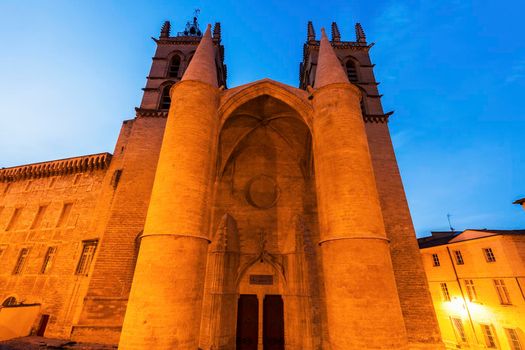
[0,18,443,350]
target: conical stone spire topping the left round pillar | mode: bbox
[181,24,218,87]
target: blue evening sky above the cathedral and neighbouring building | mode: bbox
[0,0,525,235]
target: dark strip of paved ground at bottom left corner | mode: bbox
[0,337,117,350]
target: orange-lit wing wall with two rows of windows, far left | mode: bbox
[0,154,111,337]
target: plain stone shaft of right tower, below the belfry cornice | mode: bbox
[365,123,441,348]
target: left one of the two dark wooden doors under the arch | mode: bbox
[237,294,259,350]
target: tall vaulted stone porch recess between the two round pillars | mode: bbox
[200,85,324,349]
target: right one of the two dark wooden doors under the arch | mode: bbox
[263,295,284,350]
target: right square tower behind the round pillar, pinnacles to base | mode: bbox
[299,22,442,349]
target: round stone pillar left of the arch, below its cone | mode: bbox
[119,80,219,350]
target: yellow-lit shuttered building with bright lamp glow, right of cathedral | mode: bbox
[418,229,525,350]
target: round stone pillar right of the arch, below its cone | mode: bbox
[313,83,407,350]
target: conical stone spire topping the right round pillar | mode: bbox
[315,28,348,88]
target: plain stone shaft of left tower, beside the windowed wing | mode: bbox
[72,118,166,344]
